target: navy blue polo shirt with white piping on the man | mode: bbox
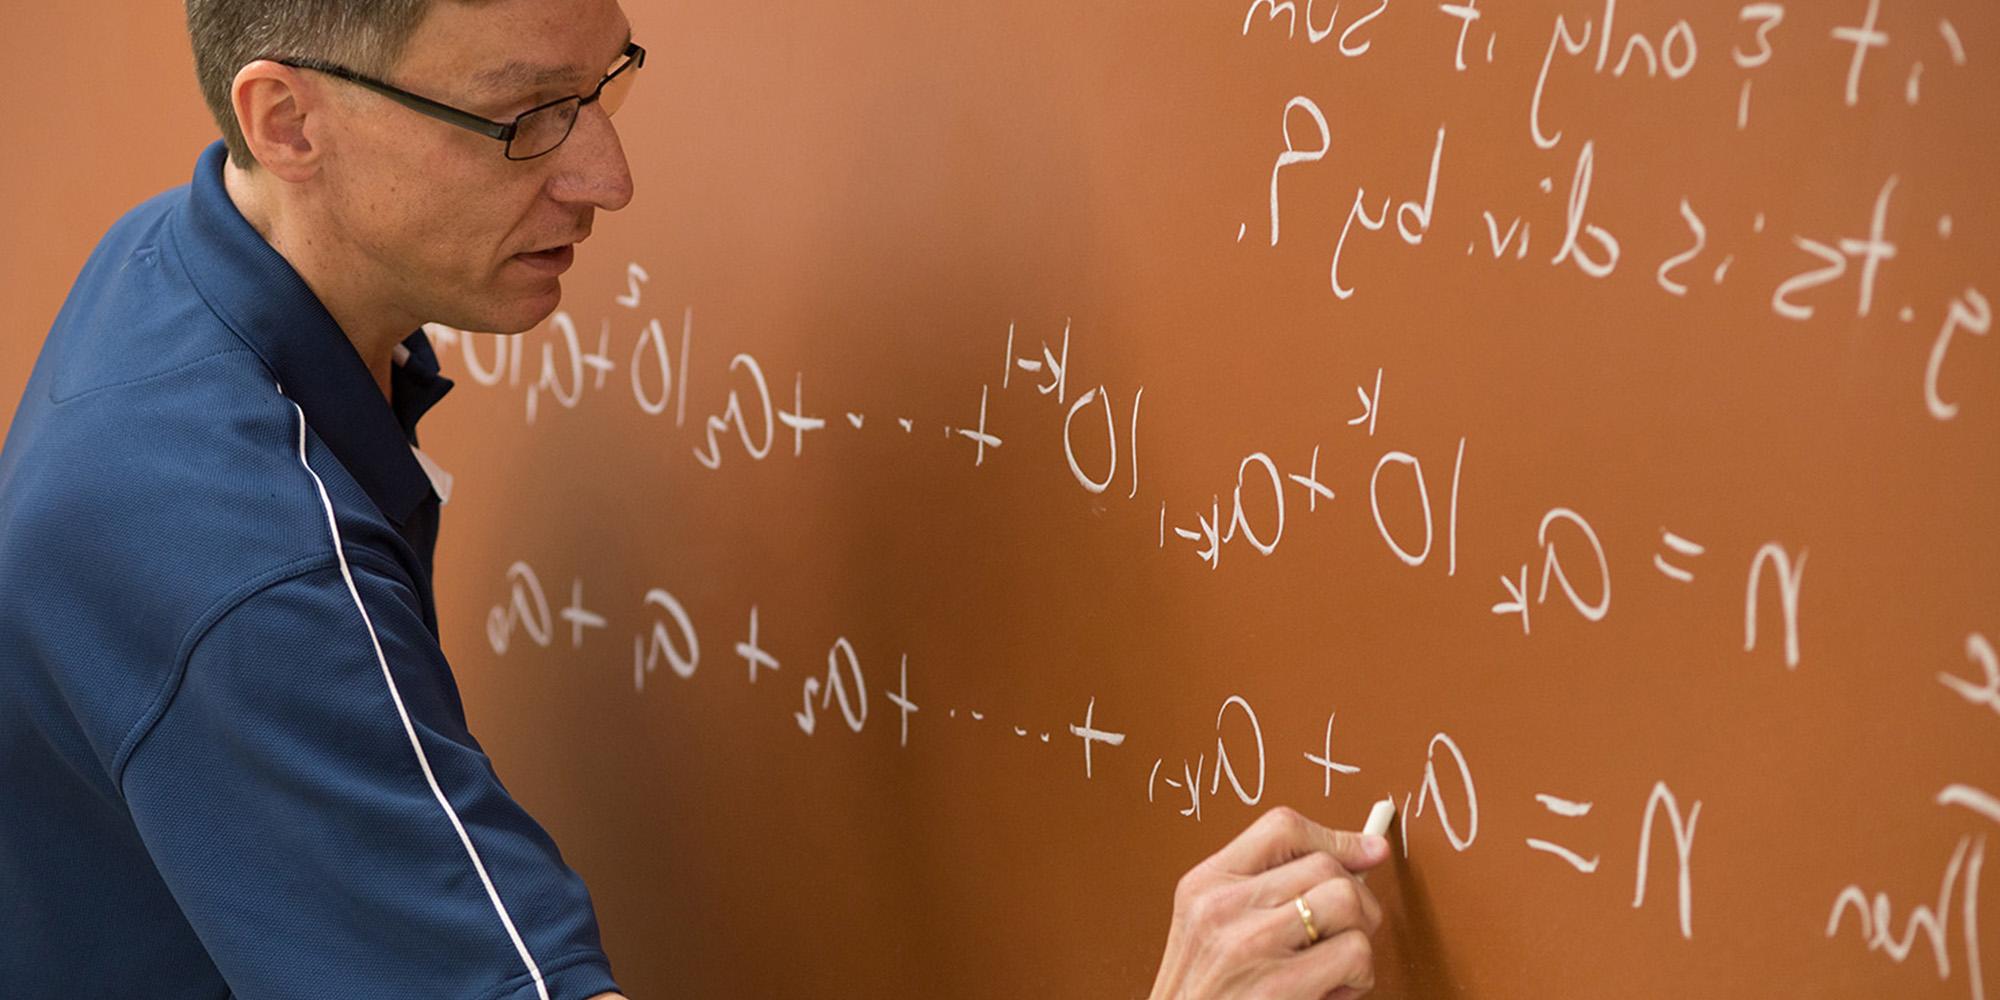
[0,144,616,1000]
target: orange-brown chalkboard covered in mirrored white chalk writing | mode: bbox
[0,0,2000,998]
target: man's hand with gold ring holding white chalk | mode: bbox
[1152,806,1388,1000]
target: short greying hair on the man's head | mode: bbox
[188,0,434,168]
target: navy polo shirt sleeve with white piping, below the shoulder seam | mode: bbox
[122,566,618,1000]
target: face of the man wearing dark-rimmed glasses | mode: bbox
[322,0,632,332]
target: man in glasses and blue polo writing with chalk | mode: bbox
[0,0,1386,1000]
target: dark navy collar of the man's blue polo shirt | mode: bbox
[174,142,452,526]
